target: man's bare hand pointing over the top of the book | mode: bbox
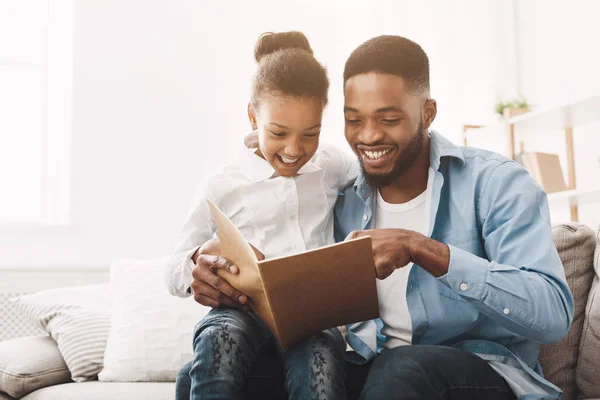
[346,229,450,279]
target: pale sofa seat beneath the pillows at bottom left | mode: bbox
[21,382,175,400]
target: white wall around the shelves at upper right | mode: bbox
[518,0,600,227]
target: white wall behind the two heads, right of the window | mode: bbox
[0,0,512,268]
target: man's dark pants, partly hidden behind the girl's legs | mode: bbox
[176,346,515,400]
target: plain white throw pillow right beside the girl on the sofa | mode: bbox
[98,258,210,382]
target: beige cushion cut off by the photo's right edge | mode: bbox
[577,230,600,398]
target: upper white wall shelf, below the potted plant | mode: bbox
[508,96,600,132]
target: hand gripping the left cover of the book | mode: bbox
[191,239,265,311]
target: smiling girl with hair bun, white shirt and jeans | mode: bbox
[167,32,358,400]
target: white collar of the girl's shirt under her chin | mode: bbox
[239,131,322,182]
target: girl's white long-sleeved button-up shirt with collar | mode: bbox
[166,138,359,297]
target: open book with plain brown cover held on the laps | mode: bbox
[208,201,379,350]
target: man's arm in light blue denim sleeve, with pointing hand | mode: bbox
[353,162,573,343]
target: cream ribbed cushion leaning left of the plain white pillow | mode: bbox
[15,285,111,382]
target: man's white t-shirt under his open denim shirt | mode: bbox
[375,168,434,349]
